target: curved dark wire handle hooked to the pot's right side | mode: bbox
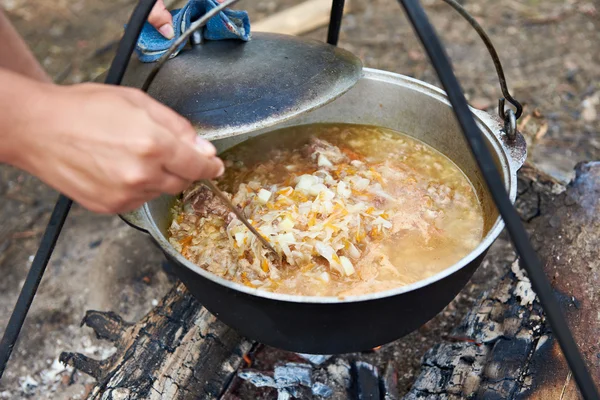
[443,0,523,141]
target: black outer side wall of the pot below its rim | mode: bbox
[170,254,485,354]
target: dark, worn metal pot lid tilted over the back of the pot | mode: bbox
[123,33,362,140]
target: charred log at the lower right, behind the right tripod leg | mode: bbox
[406,162,600,400]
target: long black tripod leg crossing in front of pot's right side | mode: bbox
[398,0,599,400]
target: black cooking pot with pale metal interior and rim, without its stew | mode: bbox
[122,68,526,354]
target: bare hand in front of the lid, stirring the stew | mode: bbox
[8,79,224,214]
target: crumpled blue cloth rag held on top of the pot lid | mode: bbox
[135,0,250,63]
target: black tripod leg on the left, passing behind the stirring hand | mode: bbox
[0,0,156,379]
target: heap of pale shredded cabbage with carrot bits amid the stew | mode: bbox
[220,148,392,280]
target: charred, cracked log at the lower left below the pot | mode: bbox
[60,284,251,400]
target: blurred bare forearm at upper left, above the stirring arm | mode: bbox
[0,9,51,82]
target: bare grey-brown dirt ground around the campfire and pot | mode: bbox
[0,0,600,399]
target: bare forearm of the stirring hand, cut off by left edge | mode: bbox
[0,68,52,169]
